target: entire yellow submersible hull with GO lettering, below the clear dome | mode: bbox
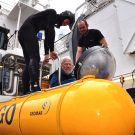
[0,76,135,135]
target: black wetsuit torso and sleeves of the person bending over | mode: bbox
[19,9,63,54]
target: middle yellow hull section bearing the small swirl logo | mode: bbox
[20,85,69,135]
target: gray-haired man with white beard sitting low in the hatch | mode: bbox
[49,56,76,87]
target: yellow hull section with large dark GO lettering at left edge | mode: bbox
[0,96,28,135]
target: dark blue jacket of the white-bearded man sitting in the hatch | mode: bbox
[49,70,76,87]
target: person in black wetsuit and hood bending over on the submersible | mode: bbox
[18,9,74,94]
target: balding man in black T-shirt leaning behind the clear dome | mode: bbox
[76,20,108,62]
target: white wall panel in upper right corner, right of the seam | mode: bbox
[116,0,135,53]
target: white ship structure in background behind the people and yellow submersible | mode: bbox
[0,0,135,95]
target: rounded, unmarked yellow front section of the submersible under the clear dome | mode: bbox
[60,76,135,135]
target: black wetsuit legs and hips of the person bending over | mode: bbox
[18,24,40,93]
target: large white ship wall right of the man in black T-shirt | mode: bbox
[87,0,135,76]
